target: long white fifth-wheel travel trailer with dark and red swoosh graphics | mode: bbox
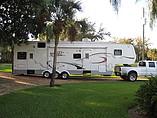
[14,41,136,78]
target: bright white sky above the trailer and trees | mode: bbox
[77,0,157,48]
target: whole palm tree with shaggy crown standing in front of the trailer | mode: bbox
[45,0,81,87]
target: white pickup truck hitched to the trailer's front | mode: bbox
[115,61,157,81]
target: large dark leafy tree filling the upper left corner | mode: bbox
[0,0,52,69]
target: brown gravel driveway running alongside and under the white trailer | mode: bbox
[0,72,147,95]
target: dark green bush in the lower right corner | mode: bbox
[136,77,157,118]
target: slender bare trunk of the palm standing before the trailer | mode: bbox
[49,35,59,87]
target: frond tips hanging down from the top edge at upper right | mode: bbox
[110,0,157,28]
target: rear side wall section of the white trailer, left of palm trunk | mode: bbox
[14,42,48,74]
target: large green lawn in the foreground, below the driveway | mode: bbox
[0,82,143,118]
